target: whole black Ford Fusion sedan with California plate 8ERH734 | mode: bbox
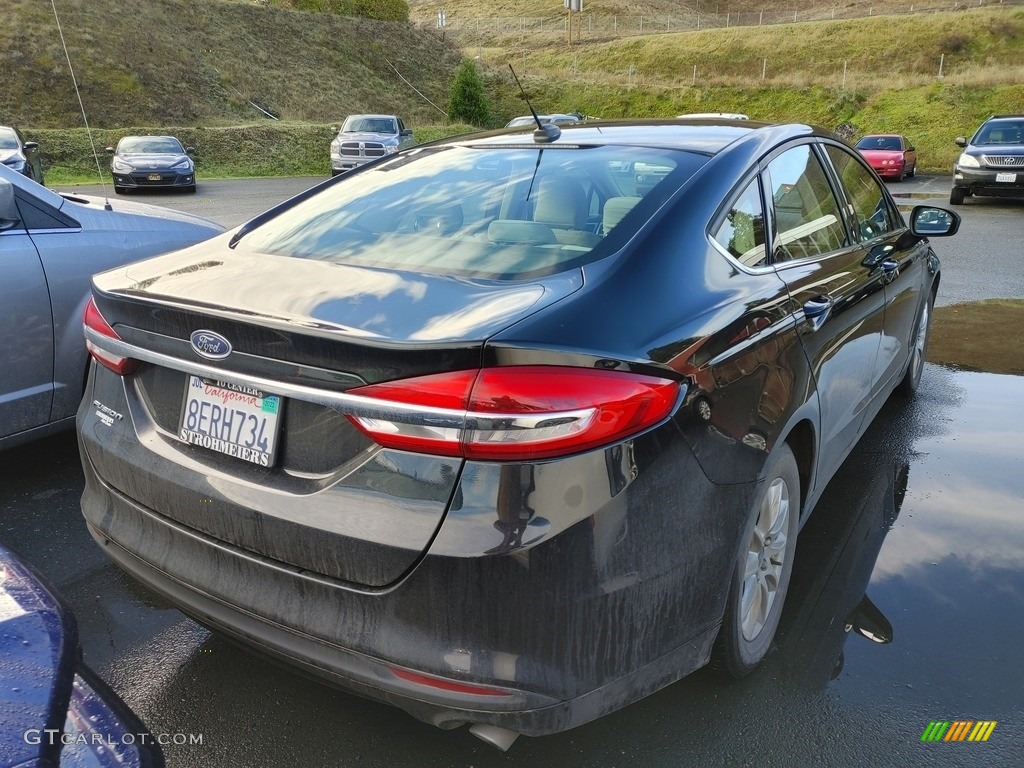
[78,121,959,749]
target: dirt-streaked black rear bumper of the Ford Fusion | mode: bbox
[79,369,753,735]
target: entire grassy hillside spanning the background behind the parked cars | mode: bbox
[8,0,1024,178]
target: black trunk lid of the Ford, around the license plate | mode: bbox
[86,247,581,588]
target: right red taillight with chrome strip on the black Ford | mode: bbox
[349,366,679,461]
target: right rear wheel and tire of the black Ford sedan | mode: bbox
[711,442,801,678]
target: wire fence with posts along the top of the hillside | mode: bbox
[415,0,1024,40]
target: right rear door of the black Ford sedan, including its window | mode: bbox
[765,143,885,479]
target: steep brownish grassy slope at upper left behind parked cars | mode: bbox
[0,0,461,127]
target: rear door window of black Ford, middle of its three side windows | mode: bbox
[768,144,849,262]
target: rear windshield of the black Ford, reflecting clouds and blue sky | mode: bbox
[245,144,707,279]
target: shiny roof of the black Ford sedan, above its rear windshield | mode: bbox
[466,119,815,155]
